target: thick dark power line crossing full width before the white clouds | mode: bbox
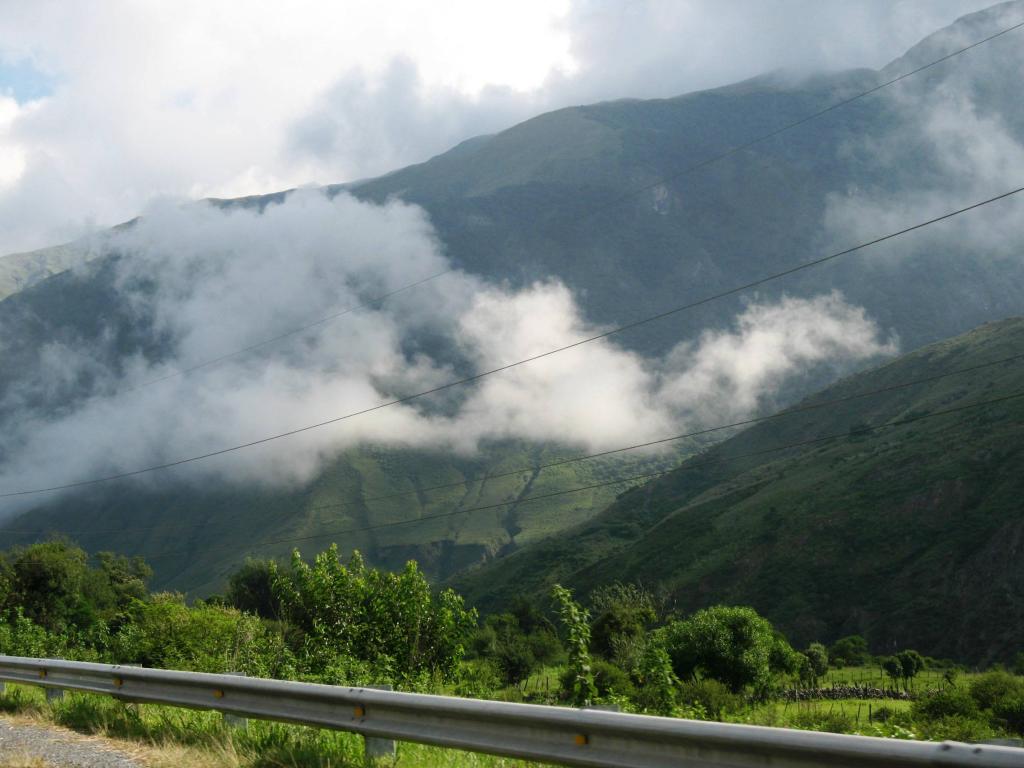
[0,186,1024,499]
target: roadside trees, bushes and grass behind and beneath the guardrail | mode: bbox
[0,540,1024,766]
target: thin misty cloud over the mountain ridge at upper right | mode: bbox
[823,4,1024,264]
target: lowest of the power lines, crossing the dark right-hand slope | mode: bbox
[119,390,1024,560]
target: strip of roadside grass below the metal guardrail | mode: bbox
[0,685,536,768]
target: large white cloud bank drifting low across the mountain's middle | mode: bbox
[0,190,893,514]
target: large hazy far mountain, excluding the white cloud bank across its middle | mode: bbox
[0,2,1024,591]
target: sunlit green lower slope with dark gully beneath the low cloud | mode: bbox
[0,443,681,594]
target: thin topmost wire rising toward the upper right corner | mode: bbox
[34,16,1024,394]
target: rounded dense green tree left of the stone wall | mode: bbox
[662,605,777,693]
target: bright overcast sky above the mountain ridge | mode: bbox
[0,0,991,254]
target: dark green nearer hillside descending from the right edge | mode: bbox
[456,317,1024,664]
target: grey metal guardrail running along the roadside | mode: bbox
[0,655,1024,768]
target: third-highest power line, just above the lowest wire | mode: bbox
[16,353,1024,534]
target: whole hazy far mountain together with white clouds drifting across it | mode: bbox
[0,2,1024,589]
